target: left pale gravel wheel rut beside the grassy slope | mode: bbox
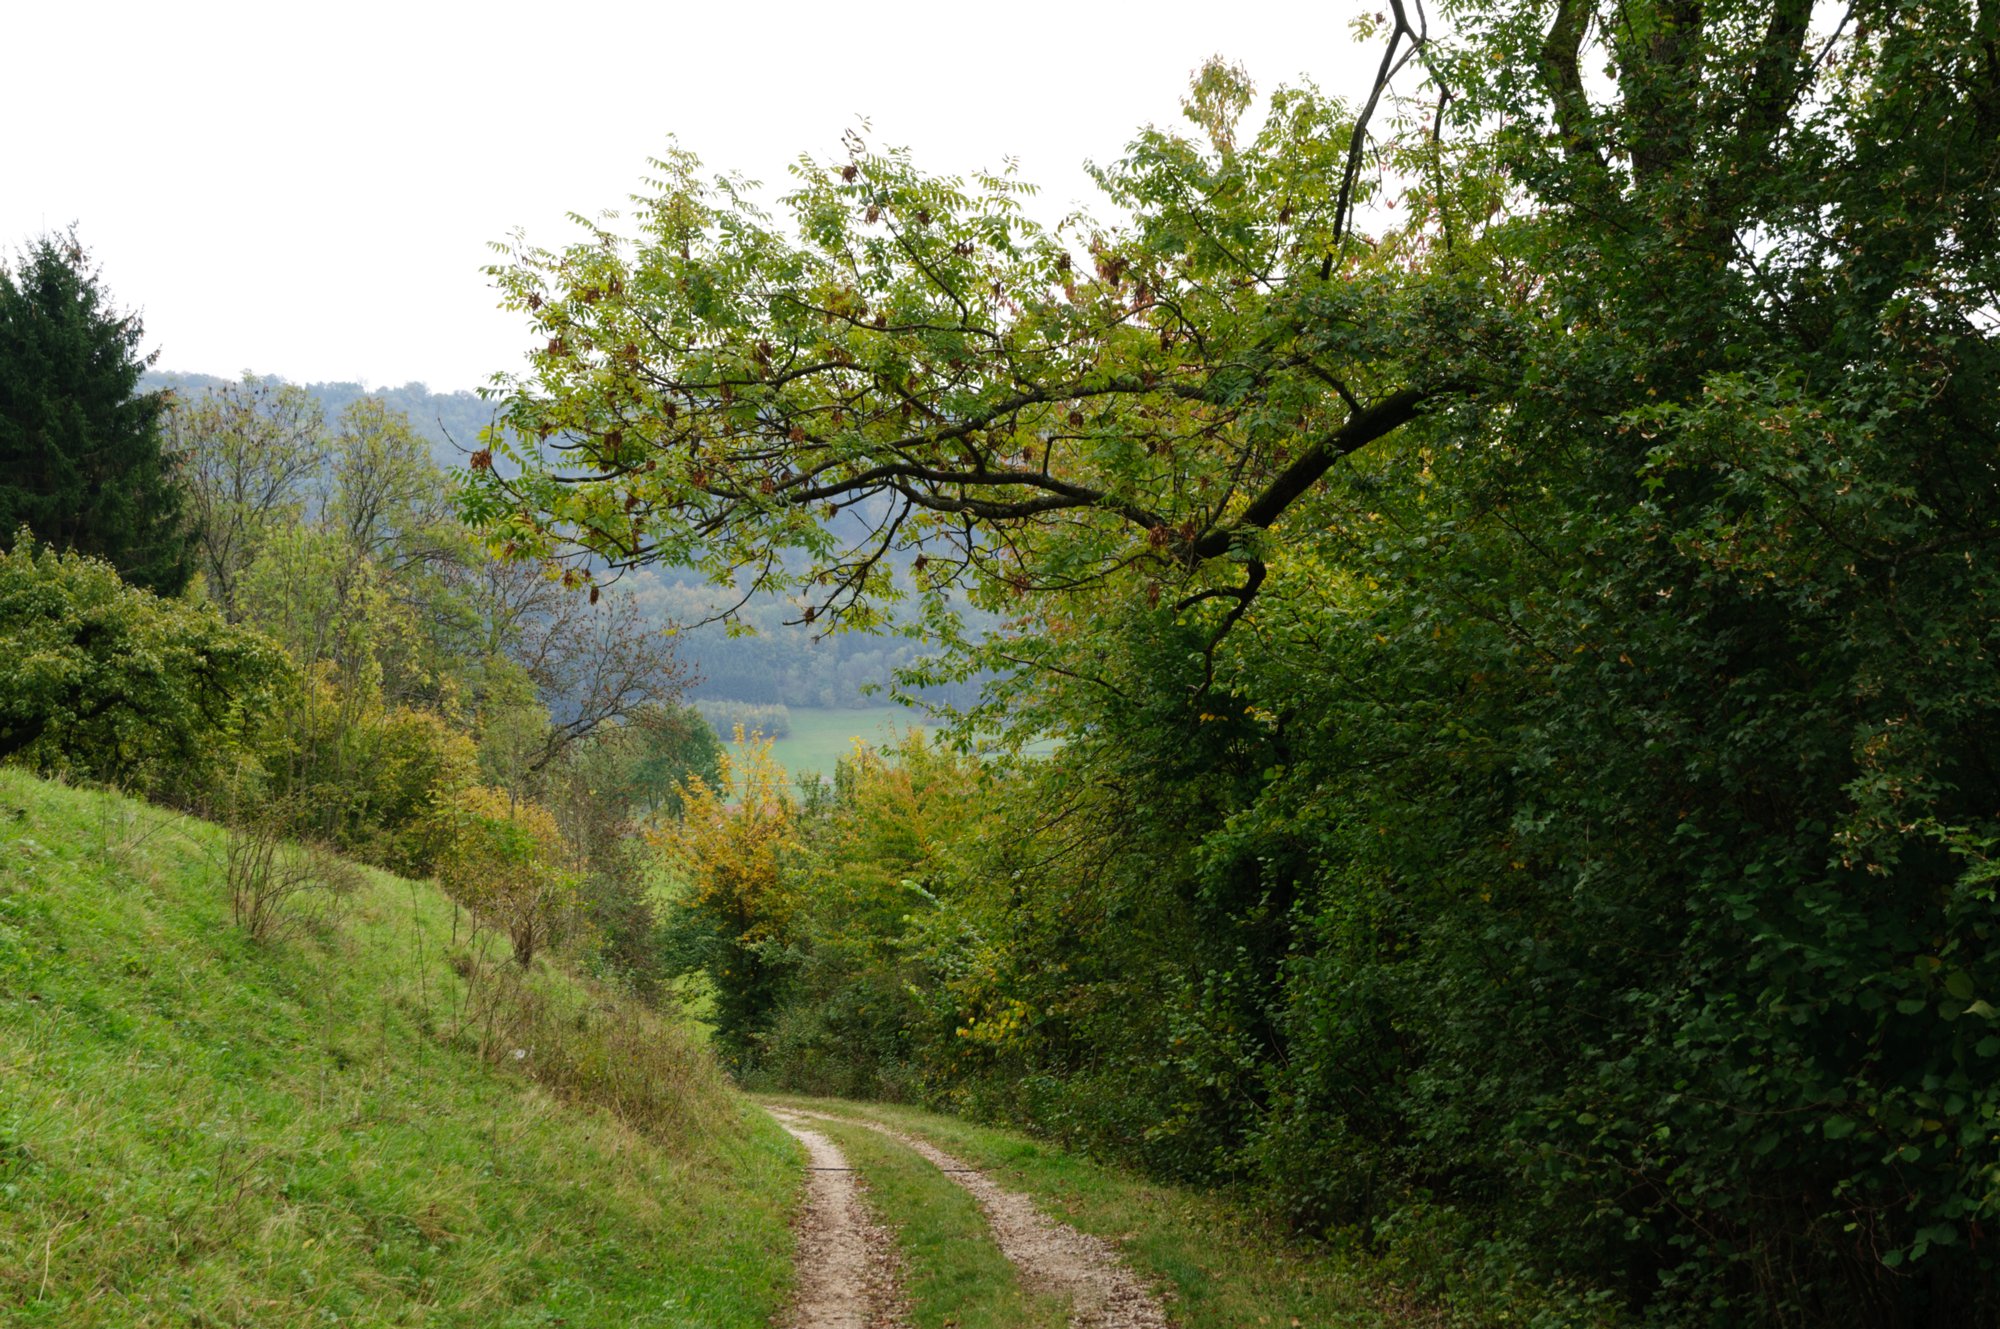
[768,1109,906,1329]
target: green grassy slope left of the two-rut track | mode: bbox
[0,771,798,1327]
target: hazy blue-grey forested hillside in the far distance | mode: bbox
[140,370,976,707]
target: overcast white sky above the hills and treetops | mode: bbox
[0,0,1378,390]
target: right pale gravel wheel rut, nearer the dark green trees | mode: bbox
[772,1109,1170,1329]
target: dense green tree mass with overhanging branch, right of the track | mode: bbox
[464,0,2000,1325]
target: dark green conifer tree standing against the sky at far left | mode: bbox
[0,232,192,594]
